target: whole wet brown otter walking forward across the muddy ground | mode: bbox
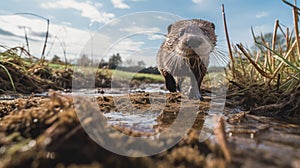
[157,19,217,100]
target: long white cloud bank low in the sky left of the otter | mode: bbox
[0,15,156,63]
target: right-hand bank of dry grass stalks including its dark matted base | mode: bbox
[223,0,300,116]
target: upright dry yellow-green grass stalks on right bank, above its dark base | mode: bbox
[227,0,300,92]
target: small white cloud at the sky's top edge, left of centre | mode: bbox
[42,0,115,23]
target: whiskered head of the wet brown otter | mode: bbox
[166,19,217,57]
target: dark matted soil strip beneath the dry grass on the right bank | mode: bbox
[226,83,300,118]
